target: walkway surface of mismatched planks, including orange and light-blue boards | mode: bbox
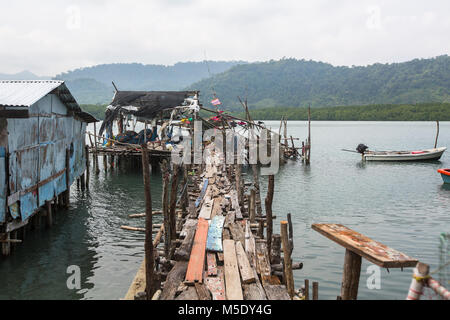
[125,146,291,300]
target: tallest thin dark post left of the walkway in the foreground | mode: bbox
[142,146,156,300]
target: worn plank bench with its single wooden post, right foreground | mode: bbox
[311,223,418,300]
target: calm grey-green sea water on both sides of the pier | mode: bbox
[0,121,450,299]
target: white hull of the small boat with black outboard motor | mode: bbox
[362,147,447,161]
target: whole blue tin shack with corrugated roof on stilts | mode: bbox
[0,80,97,255]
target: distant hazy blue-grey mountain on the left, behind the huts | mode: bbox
[54,61,245,104]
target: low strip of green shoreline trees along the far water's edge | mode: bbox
[80,103,450,121]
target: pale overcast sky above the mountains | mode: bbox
[0,0,450,76]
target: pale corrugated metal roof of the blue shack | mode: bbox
[0,80,64,107]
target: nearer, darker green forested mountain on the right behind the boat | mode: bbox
[188,55,450,111]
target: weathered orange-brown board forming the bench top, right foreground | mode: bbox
[312,223,418,268]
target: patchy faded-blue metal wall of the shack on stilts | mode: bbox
[0,95,86,223]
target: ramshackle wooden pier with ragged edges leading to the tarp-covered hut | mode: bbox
[125,145,301,300]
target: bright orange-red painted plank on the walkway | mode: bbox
[185,218,208,284]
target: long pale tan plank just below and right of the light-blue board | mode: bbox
[223,240,244,300]
